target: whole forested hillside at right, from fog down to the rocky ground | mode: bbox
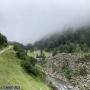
[34,27,90,53]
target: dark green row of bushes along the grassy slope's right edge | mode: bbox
[14,45,38,76]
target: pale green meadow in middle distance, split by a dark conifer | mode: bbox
[28,50,52,58]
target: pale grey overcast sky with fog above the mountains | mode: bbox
[0,0,90,43]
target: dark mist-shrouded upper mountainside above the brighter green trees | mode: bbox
[34,26,90,50]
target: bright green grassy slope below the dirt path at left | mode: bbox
[0,49,50,90]
